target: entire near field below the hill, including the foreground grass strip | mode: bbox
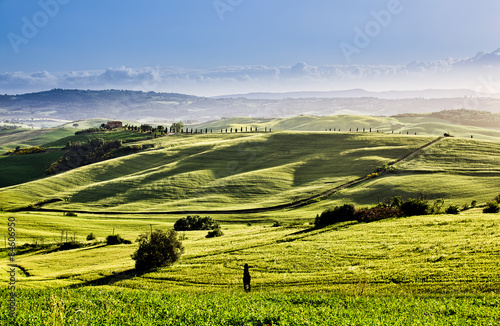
[1,209,500,325]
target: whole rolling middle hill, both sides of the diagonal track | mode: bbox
[0,132,500,212]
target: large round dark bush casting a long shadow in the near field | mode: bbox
[132,230,184,270]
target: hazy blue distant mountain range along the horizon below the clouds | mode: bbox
[0,89,500,125]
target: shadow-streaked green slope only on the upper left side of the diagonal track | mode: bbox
[0,133,431,211]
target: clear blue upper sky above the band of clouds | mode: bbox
[0,0,500,92]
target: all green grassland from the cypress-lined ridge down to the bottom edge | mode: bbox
[0,116,500,325]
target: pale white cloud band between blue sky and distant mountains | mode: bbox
[0,48,500,96]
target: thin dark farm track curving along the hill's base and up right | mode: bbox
[33,137,444,215]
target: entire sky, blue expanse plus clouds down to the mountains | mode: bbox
[0,0,500,95]
